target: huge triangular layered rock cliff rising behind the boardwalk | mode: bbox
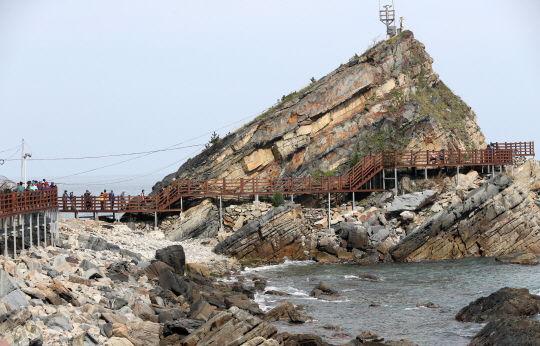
[154,31,486,191]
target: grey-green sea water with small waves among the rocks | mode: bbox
[242,258,540,346]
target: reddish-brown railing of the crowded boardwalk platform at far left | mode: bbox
[0,189,58,218]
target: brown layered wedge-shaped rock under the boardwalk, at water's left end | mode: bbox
[214,202,315,260]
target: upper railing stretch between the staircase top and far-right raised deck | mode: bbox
[383,149,513,168]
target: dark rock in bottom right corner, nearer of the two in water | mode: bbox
[469,317,540,346]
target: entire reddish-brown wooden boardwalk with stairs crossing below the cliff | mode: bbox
[0,142,534,218]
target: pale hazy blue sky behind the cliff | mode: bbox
[0,0,540,187]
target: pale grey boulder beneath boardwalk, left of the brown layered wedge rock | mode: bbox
[167,199,219,241]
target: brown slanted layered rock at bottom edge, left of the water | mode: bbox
[180,307,277,346]
